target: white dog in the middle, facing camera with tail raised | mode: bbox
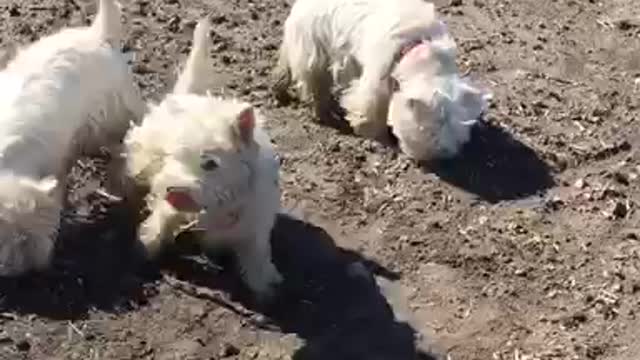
[124,20,282,298]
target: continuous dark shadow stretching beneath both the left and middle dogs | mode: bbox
[0,154,435,360]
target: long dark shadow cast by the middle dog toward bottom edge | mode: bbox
[164,216,436,360]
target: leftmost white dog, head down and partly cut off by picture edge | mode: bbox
[0,0,144,276]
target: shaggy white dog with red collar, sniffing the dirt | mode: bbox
[274,0,486,160]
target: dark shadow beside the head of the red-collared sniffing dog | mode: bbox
[422,121,554,203]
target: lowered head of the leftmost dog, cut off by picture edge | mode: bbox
[0,174,62,276]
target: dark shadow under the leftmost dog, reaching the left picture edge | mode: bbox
[0,156,158,320]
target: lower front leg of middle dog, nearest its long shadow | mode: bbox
[234,232,282,300]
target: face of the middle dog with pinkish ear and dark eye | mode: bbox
[156,95,258,228]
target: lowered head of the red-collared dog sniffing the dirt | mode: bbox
[389,32,488,160]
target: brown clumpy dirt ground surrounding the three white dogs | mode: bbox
[0,0,640,360]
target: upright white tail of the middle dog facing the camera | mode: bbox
[173,18,211,95]
